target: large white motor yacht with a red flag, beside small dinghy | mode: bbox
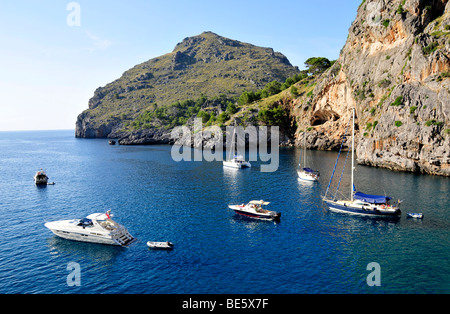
[45,210,136,246]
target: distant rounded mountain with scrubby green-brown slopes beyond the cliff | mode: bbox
[75,32,299,138]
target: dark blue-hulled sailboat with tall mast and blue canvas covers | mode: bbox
[323,109,401,217]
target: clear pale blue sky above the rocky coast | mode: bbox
[0,0,361,131]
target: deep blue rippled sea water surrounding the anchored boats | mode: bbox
[0,130,450,295]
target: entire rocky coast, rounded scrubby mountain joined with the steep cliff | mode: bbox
[76,0,450,176]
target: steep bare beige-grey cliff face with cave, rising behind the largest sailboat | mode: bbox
[292,0,450,176]
